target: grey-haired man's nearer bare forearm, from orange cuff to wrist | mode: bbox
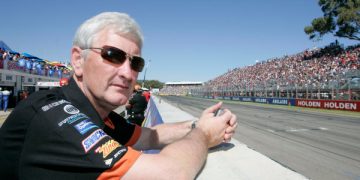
[123,129,208,179]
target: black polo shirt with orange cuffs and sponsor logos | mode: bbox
[0,79,141,179]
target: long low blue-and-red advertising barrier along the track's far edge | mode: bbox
[203,96,360,112]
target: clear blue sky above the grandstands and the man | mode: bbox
[0,0,357,82]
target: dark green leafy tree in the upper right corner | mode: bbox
[304,0,360,41]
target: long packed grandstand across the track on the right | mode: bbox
[164,43,360,100]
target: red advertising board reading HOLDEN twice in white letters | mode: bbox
[295,99,360,111]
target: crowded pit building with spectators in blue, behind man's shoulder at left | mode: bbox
[0,41,71,107]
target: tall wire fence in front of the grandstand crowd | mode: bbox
[189,70,360,100]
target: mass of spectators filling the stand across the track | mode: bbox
[161,43,360,99]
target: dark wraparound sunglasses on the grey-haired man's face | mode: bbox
[84,46,145,72]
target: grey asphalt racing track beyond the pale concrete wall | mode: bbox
[161,96,360,180]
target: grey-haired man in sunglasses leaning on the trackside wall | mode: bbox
[0,12,237,179]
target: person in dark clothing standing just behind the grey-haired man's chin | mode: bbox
[126,84,147,126]
